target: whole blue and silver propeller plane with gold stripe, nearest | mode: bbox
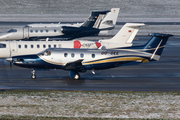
[6,33,172,80]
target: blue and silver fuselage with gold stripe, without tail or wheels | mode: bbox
[12,49,153,72]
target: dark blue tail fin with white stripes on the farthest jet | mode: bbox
[81,10,110,28]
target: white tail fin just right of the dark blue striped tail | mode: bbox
[99,8,120,32]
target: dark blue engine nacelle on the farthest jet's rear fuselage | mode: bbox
[61,26,82,34]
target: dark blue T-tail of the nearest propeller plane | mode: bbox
[143,33,173,60]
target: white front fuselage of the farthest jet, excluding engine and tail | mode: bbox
[0,23,82,41]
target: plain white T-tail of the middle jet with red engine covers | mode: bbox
[99,23,145,47]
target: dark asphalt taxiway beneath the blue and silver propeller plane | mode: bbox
[0,36,180,91]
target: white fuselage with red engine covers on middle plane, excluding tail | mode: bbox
[0,40,101,59]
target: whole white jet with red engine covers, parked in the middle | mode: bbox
[0,23,145,59]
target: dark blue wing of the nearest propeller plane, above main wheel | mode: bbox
[65,59,87,72]
